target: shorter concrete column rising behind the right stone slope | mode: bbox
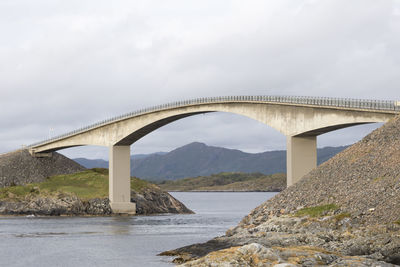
[286,136,317,186]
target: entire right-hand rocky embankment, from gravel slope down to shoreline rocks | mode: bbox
[164,117,400,266]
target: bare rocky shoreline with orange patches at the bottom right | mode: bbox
[160,213,400,266]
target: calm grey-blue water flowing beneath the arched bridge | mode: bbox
[0,192,275,267]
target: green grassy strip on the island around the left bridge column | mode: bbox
[0,168,156,201]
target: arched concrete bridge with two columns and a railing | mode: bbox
[29,96,400,216]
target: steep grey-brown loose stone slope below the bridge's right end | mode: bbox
[241,116,400,225]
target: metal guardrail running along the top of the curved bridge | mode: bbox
[28,96,400,148]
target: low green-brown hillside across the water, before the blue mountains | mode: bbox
[158,173,286,192]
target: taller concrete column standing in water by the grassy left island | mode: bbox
[109,146,136,214]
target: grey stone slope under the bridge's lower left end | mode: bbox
[0,149,85,187]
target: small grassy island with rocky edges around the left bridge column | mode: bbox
[0,150,193,216]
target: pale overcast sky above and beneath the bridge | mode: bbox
[0,0,400,158]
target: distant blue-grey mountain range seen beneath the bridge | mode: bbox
[74,142,347,181]
